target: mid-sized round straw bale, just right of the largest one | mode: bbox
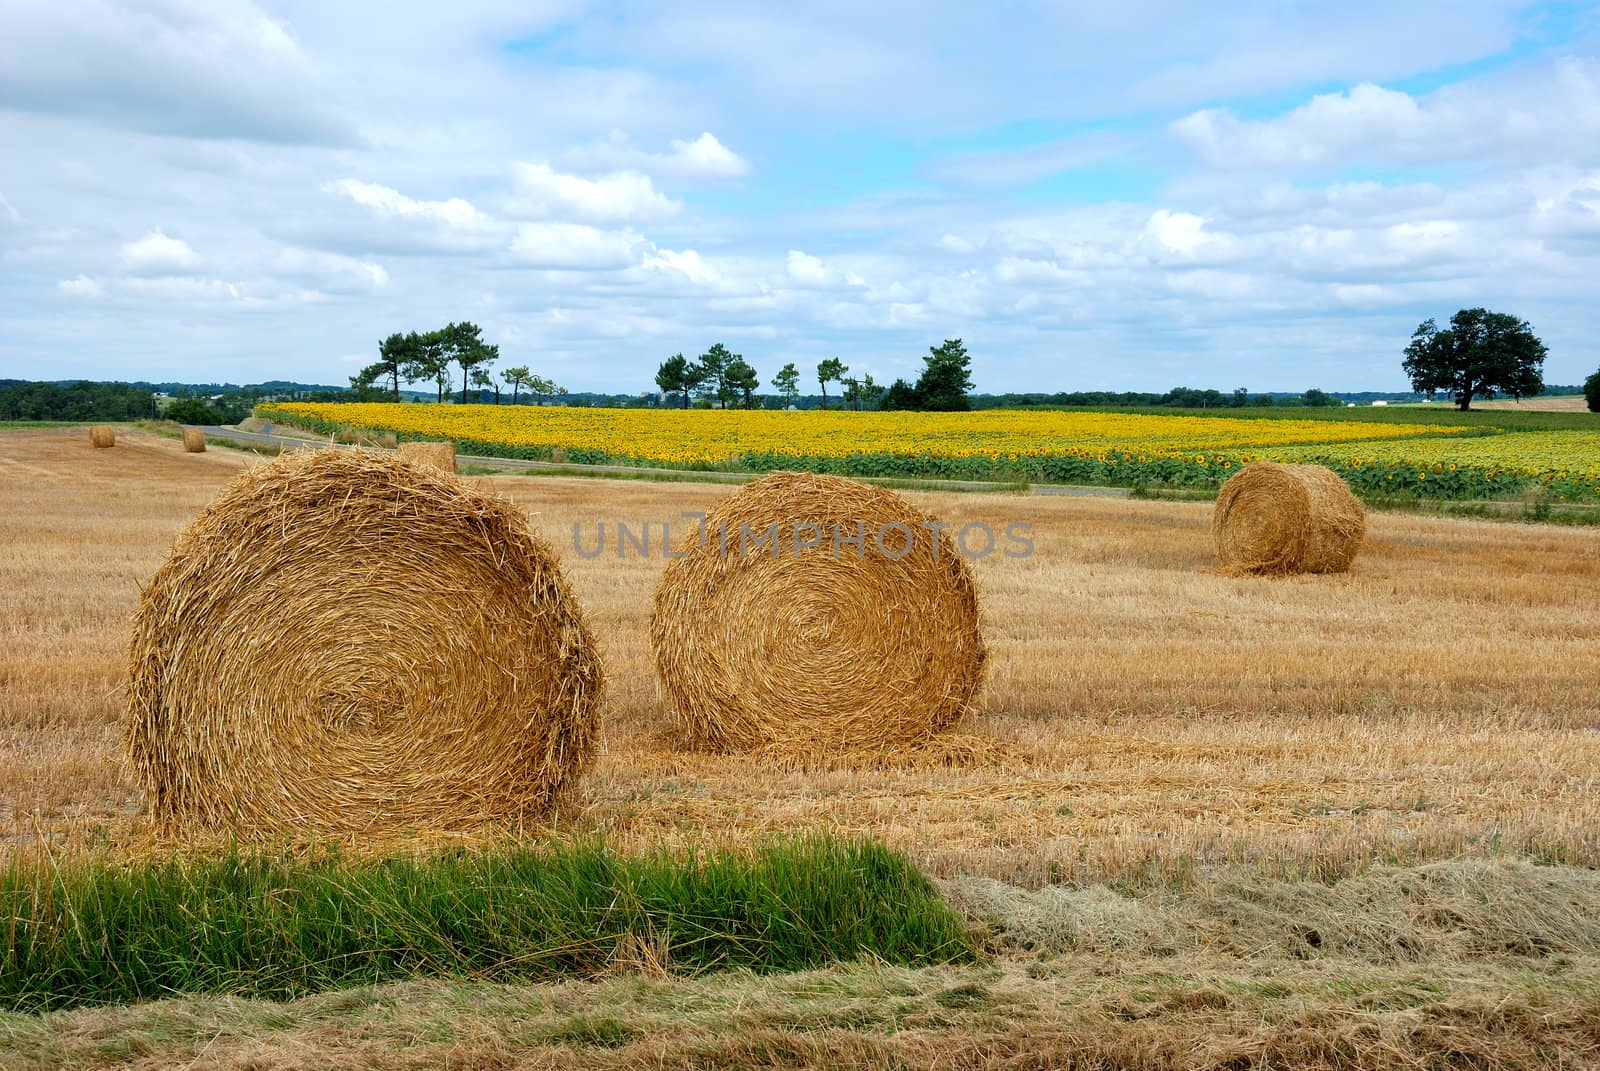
[650,472,986,751]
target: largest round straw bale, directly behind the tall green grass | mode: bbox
[125,450,603,834]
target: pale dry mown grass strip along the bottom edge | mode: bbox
[0,860,1600,1071]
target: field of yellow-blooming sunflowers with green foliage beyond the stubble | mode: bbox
[258,402,1600,501]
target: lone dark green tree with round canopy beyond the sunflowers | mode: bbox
[1403,309,1547,411]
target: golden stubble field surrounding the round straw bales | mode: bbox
[0,429,1600,885]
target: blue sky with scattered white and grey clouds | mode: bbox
[0,0,1600,391]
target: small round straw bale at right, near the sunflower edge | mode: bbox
[1211,461,1366,575]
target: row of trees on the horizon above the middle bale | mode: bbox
[656,338,973,411]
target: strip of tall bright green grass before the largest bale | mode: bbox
[0,837,973,1010]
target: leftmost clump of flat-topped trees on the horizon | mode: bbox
[350,320,566,405]
